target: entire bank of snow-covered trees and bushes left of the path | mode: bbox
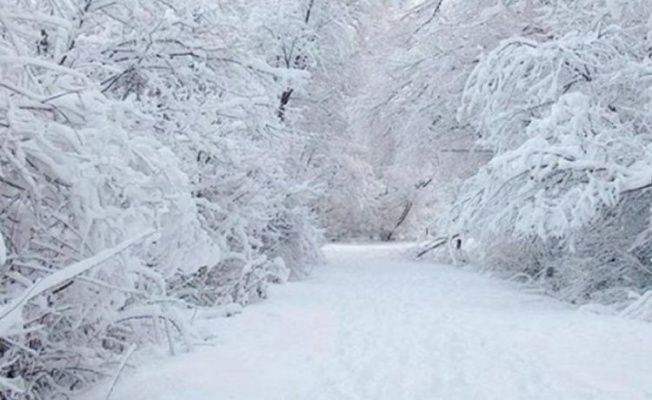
[0,0,362,399]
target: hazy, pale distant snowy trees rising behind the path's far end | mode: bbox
[332,0,526,239]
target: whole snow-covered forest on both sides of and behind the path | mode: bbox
[0,0,652,400]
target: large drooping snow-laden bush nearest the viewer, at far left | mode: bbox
[0,5,219,398]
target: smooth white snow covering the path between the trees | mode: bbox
[81,245,652,400]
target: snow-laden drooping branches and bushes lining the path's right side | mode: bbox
[452,1,652,302]
